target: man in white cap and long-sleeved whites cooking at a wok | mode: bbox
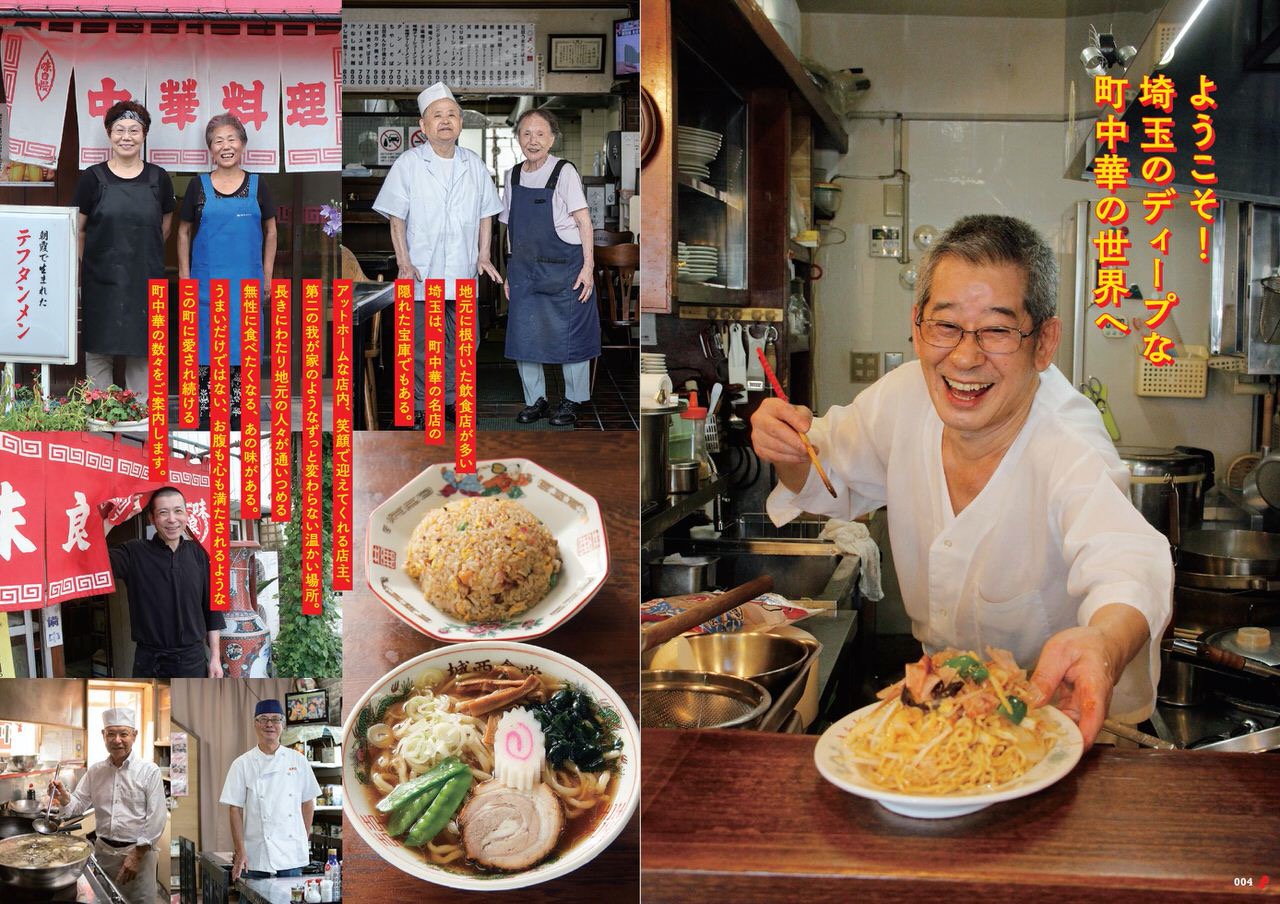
[49,707,169,904]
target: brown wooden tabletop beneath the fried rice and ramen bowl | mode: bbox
[342,430,640,904]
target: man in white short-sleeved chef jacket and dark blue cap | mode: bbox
[220,700,320,882]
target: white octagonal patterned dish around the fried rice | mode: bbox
[365,458,609,643]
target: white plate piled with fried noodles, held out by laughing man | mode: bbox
[814,648,1084,818]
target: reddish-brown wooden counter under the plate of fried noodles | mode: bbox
[640,729,1280,904]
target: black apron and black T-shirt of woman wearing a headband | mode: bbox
[81,164,165,357]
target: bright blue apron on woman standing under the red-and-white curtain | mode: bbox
[191,173,262,367]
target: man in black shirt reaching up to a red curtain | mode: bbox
[109,487,227,677]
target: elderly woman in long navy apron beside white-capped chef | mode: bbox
[499,110,600,426]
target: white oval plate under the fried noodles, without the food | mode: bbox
[813,702,1084,819]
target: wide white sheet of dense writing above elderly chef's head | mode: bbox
[342,22,538,92]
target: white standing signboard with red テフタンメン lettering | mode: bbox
[0,204,78,364]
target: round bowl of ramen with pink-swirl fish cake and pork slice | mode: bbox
[342,640,640,890]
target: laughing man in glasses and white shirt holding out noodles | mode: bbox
[751,215,1172,744]
